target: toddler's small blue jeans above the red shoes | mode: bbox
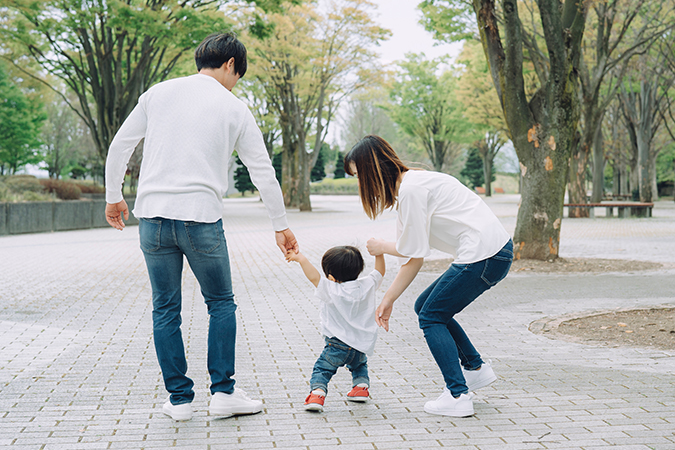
[309,337,370,393]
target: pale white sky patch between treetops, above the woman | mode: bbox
[364,0,462,63]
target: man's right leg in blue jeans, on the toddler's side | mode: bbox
[177,221,237,394]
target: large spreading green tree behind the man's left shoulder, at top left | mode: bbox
[0,0,276,163]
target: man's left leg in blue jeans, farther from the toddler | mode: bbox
[138,218,194,405]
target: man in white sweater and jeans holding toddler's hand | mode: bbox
[105,33,298,420]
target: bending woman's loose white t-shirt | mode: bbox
[396,170,511,264]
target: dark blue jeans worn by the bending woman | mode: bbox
[415,240,513,397]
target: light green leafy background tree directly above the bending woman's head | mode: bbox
[387,54,463,172]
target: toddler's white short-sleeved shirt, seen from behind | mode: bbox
[316,270,382,355]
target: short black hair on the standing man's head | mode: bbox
[195,33,247,77]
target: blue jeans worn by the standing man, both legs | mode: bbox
[138,217,237,405]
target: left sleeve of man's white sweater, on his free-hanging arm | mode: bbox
[105,101,147,203]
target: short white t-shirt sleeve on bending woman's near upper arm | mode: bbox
[396,186,431,258]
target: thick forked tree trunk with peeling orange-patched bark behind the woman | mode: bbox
[423,0,588,260]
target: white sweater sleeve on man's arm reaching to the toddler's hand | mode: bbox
[235,108,288,231]
